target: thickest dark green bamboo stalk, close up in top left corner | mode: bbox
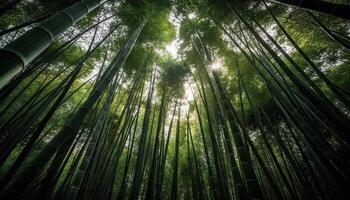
[0,0,106,89]
